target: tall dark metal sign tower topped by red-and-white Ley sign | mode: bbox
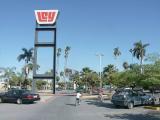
[32,10,58,94]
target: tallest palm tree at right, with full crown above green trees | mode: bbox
[132,40,149,74]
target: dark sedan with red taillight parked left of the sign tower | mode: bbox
[0,89,40,104]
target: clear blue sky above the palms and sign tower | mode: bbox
[0,0,160,71]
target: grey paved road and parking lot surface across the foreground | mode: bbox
[0,96,160,120]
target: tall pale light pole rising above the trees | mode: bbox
[96,53,104,88]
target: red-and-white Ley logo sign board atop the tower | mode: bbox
[35,10,58,24]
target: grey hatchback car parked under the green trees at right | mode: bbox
[111,89,155,109]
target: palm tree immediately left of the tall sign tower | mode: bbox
[17,48,33,88]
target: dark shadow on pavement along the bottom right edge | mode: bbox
[105,113,160,120]
